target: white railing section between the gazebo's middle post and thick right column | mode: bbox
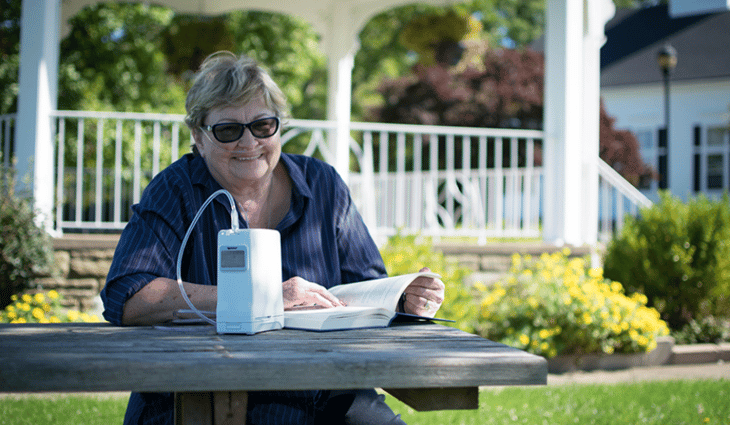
[350,123,542,243]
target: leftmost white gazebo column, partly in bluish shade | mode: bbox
[15,0,61,230]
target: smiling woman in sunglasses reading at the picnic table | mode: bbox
[101,52,444,424]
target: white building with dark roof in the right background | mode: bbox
[601,5,730,200]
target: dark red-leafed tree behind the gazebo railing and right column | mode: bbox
[371,49,653,185]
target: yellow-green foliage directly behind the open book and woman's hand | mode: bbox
[380,233,475,332]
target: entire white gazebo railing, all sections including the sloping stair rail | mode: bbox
[0,111,650,242]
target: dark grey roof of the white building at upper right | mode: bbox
[601,5,730,87]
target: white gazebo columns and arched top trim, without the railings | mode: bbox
[14,0,712,246]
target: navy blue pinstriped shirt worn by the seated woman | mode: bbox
[101,154,386,424]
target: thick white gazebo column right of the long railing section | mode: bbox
[543,0,615,246]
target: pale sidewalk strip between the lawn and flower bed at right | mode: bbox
[548,361,730,385]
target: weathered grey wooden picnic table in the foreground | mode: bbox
[0,323,547,424]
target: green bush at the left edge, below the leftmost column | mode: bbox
[0,165,53,308]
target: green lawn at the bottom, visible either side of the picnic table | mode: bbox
[0,380,730,425]
